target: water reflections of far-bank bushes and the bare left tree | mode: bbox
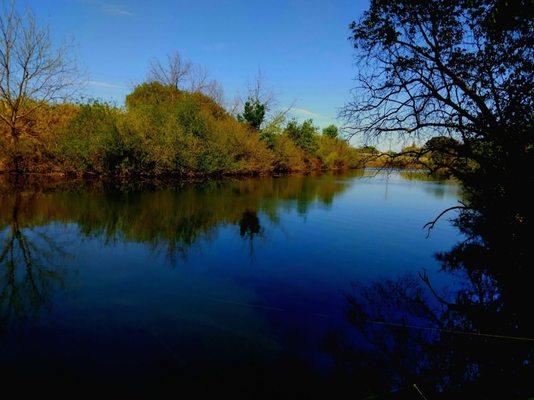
[0,172,359,327]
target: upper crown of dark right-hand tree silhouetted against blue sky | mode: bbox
[343,0,533,147]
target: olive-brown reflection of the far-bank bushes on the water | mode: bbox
[0,174,356,264]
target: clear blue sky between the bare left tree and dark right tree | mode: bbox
[22,0,367,126]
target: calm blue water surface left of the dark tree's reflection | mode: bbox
[0,171,459,394]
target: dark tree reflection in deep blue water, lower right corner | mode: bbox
[328,210,534,398]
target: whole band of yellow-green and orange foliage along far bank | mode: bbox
[0,82,359,177]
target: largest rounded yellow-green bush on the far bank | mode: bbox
[55,83,273,176]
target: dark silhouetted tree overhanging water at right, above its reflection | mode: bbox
[342,0,534,244]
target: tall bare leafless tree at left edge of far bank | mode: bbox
[0,2,76,172]
